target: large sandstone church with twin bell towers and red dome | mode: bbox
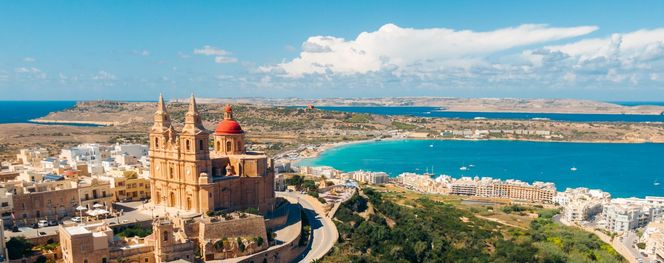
[149,95,275,213]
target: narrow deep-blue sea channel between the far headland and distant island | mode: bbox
[318,106,664,122]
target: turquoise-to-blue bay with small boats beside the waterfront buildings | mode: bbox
[300,140,664,197]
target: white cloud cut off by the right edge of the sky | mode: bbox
[523,29,664,85]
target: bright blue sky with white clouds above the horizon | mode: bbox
[0,1,664,101]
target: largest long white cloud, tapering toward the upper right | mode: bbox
[268,24,597,77]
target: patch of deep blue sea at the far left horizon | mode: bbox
[0,101,87,124]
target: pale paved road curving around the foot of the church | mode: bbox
[277,192,339,262]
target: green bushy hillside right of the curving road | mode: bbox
[324,189,624,262]
